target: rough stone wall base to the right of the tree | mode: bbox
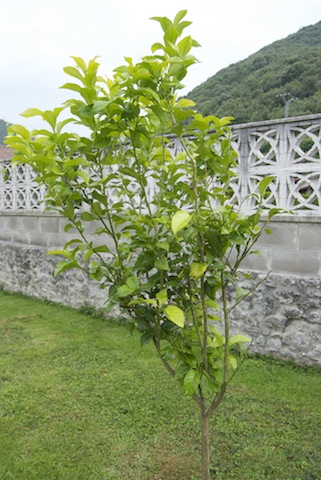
[232,274,321,366]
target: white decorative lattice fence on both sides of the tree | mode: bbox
[0,114,321,216]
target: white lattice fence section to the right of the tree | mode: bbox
[233,115,321,215]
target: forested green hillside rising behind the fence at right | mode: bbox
[188,21,321,123]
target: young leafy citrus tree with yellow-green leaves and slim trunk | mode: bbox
[7,11,274,480]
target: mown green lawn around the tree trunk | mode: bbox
[0,292,321,480]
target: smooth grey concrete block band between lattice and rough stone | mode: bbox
[0,212,321,278]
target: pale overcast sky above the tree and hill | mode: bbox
[0,0,321,128]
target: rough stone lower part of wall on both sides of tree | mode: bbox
[0,243,321,365]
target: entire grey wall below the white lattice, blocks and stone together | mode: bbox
[0,214,321,365]
